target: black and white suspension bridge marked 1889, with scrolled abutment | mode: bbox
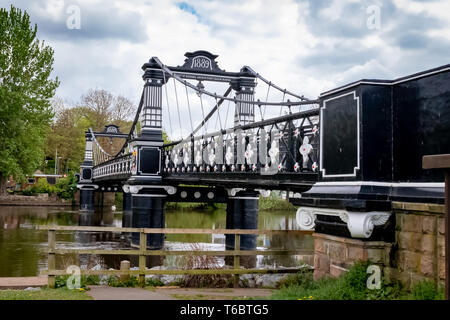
[78,51,450,250]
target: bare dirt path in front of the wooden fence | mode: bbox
[87,286,273,300]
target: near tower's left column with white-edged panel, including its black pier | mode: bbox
[123,58,167,249]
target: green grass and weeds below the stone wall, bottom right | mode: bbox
[271,262,444,300]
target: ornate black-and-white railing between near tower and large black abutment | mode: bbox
[163,108,319,175]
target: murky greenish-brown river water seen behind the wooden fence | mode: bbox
[0,206,314,277]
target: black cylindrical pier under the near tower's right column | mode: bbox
[225,191,259,250]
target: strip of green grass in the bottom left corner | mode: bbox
[0,288,92,300]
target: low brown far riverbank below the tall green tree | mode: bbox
[0,193,73,206]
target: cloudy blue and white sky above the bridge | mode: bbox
[0,0,450,138]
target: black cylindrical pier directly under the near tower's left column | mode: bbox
[131,194,166,250]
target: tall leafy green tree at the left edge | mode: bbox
[0,6,59,192]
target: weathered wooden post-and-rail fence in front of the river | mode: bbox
[38,226,312,288]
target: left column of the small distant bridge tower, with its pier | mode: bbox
[77,131,98,211]
